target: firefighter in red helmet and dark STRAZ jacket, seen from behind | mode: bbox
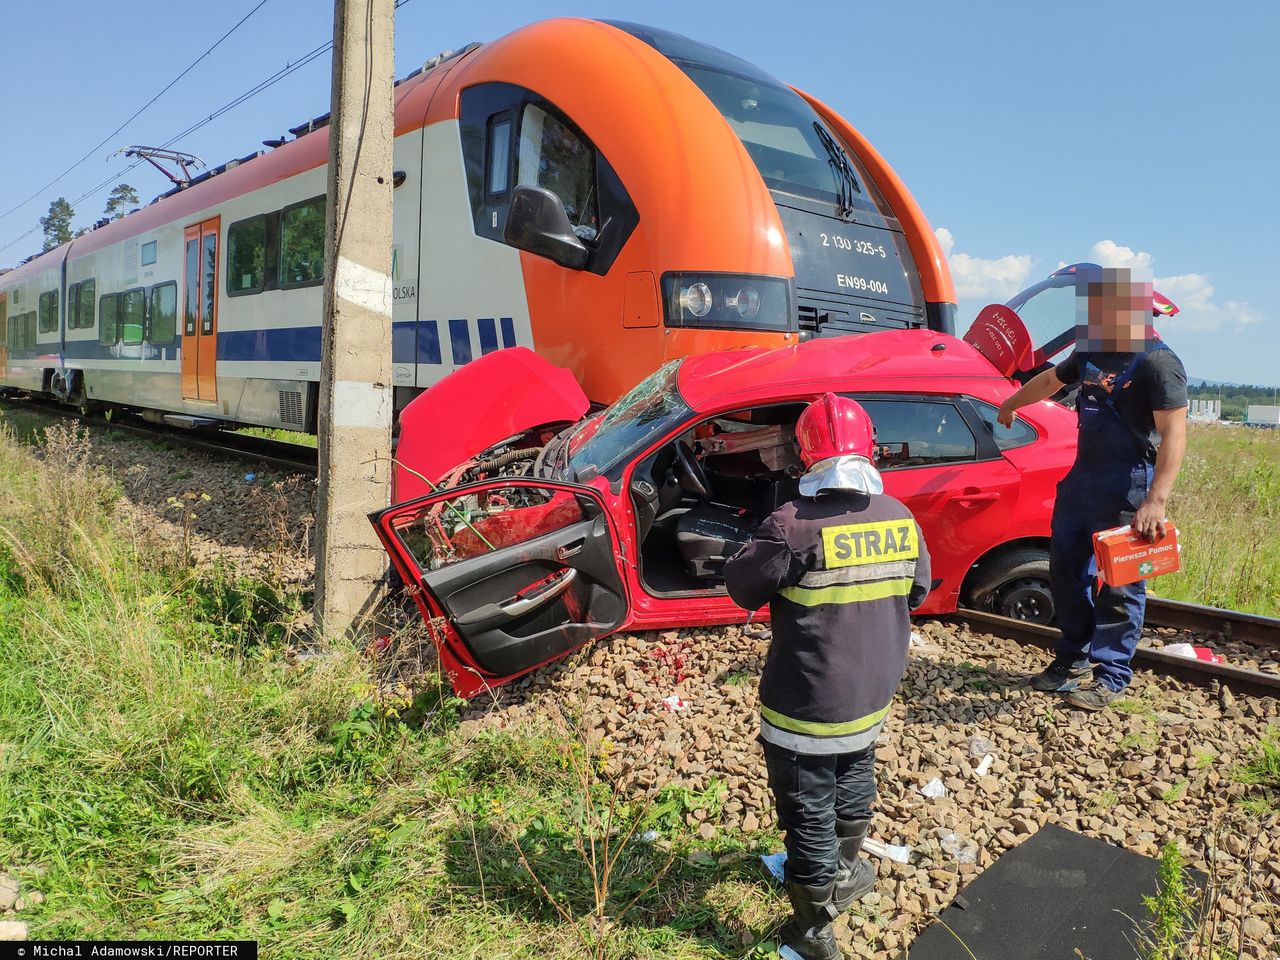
[724,393,929,960]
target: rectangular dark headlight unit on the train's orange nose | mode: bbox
[662,273,796,332]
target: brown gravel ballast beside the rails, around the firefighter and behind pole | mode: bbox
[22,417,1280,960]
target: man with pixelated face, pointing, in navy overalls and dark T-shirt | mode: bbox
[996,265,1187,710]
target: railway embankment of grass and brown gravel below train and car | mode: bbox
[0,409,1280,960]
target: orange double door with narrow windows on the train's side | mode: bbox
[182,216,221,401]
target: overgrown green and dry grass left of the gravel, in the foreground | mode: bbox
[0,428,783,960]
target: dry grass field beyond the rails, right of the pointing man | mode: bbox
[1149,424,1280,617]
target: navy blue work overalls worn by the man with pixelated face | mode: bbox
[1050,343,1167,690]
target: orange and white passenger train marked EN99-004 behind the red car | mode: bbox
[0,19,956,430]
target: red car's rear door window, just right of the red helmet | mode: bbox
[856,397,978,470]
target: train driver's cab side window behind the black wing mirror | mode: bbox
[516,104,600,241]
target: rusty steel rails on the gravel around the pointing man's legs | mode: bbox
[948,598,1280,698]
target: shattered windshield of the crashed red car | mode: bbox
[568,360,694,479]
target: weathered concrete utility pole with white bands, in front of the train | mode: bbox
[316,0,396,637]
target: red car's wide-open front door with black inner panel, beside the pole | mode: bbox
[370,477,627,698]
